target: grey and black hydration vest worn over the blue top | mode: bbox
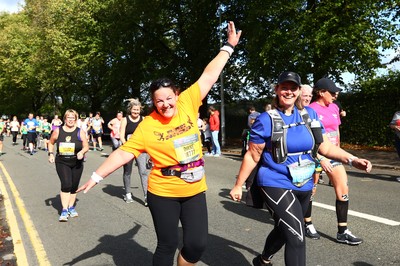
[267,108,319,163]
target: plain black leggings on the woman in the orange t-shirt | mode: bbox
[147,192,208,266]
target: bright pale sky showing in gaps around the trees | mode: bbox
[0,0,400,84]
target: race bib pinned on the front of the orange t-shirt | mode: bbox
[174,134,201,164]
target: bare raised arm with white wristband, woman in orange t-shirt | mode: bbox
[197,21,242,99]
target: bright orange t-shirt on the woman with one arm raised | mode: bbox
[121,82,207,197]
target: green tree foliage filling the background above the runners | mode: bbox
[0,0,400,145]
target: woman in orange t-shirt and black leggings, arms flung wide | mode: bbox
[79,22,241,266]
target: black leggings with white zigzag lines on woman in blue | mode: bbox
[262,187,311,266]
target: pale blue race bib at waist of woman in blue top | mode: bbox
[288,156,315,187]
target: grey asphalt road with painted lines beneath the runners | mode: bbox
[0,139,400,266]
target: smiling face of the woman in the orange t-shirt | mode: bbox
[153,87,178,118]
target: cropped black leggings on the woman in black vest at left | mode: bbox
[56,161,83,194]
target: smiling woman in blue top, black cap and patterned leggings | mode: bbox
[230,72,372,266]
